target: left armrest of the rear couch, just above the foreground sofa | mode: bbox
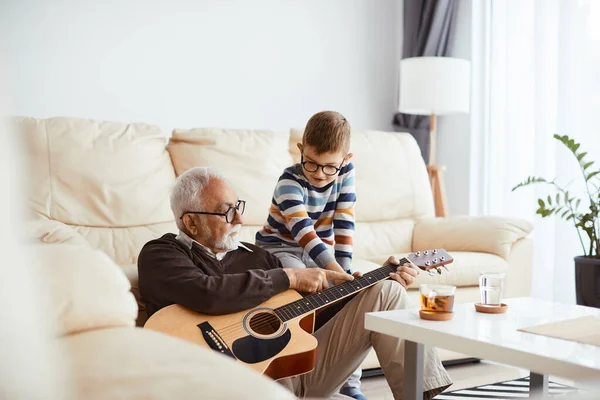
[25,219,90,246]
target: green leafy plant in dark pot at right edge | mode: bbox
[512,134,600,307]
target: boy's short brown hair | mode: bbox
[302,111,350,154]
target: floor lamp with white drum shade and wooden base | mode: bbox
[398,57,471,217]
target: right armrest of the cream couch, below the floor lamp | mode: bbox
[412,216,533,260]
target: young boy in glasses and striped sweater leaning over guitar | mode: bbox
[256,111,365,399]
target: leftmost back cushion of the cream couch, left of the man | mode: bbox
[15,118,175,227]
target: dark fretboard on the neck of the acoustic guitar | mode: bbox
[273,258,409,322]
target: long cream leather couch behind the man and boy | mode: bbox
[16,118,532,369]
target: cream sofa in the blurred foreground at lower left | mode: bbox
[28,243,295,400]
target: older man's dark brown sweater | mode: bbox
[138,233,290,316]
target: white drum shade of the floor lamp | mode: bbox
[398,57,471,115]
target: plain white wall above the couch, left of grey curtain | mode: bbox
[0,0,402,130]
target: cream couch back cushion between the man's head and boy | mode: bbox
[167,128,292,226]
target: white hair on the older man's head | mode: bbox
[171,167,225,230]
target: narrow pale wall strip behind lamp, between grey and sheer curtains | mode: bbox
[438,0,476,215]
